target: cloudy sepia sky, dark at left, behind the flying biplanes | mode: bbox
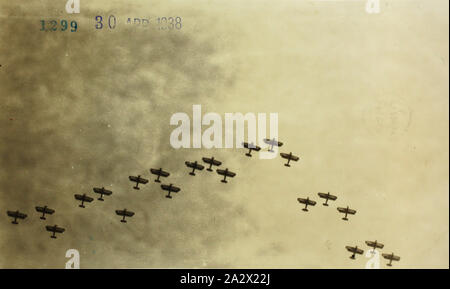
[0,0,449,268]
